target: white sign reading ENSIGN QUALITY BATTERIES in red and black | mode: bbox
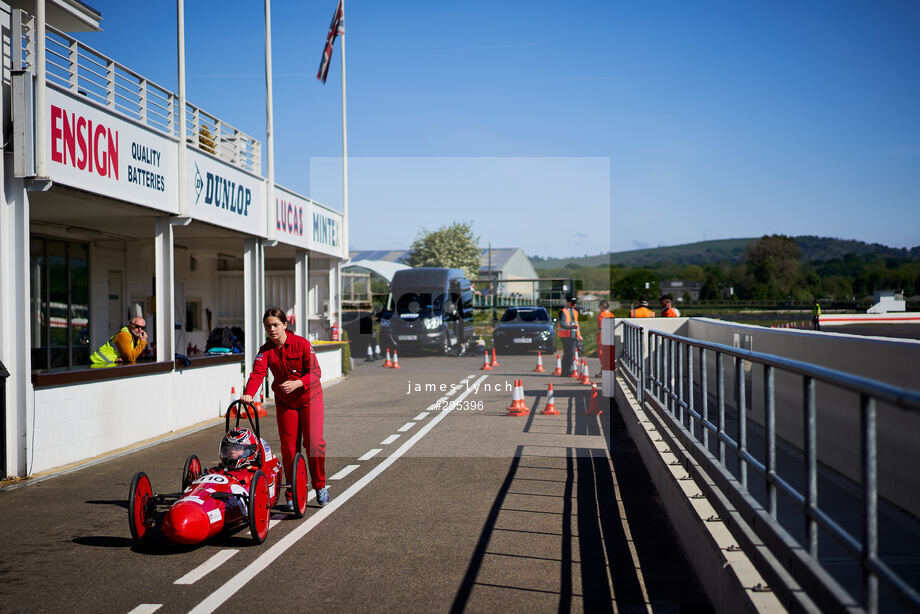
[46,88,178,213]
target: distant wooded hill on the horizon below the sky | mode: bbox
[531,235,920,269]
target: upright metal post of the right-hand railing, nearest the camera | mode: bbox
[859,394,878,614]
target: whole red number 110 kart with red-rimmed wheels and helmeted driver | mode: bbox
[128,401,307,544]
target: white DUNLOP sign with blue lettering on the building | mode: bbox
[187,149,266,237]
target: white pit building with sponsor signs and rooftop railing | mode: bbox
[0,0,347,478]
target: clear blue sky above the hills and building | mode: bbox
[79,0,920,256]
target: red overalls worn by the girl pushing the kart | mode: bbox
[243,331,326,490]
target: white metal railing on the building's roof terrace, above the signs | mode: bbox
[12,9,262,175]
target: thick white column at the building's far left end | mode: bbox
[0,179,36,478]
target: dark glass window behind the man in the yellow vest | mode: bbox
[30,237,89,369]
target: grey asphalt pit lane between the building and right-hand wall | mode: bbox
[0,356,711,612]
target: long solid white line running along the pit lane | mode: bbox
[189,375,488,614]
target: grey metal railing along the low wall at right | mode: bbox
[618,322,920,614]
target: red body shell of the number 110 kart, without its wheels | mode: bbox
[163,441,281,544]
